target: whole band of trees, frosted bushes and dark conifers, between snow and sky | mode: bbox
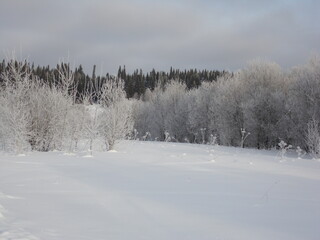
[0,57,320,156]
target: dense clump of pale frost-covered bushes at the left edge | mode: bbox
[0,58,77,152]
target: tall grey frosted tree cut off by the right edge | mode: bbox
[284,56,320,150]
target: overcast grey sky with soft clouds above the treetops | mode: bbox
[0,0,320,74]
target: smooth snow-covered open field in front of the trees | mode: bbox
[0,141,320,240]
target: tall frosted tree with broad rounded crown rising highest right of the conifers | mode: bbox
[239,60,286,149]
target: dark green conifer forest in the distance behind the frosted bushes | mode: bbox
[0,60,225,101]
